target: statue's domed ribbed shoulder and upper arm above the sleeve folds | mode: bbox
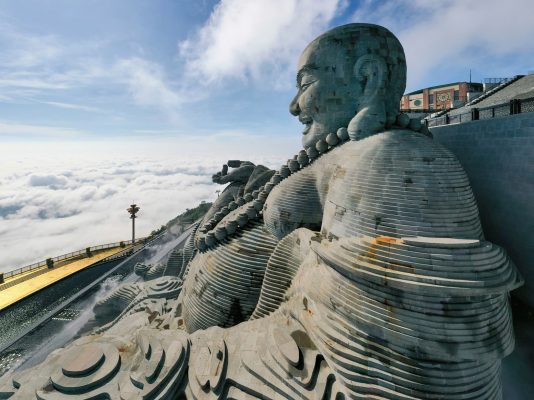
[321,130,482,239]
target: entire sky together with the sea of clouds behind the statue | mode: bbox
[0,0,534,270]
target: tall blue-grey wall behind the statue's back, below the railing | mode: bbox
[430,113,534,307]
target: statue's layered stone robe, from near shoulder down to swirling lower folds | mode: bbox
[0,130,521,400]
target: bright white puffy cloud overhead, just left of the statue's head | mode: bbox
[180,0,345,87]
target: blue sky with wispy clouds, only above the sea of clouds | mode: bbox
[0,0,534,148]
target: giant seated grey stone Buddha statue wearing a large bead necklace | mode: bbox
[0,24,522,400]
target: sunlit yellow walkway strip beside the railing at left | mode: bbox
[0,247,124,310]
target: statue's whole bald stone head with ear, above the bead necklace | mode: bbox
[290,24,406,147]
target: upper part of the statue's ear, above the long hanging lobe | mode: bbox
[354,54,387,99]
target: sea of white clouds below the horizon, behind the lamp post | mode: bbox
[0,142,288,271]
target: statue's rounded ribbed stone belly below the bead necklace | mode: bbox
[183,222,277,332]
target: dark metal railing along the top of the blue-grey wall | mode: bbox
[425,97,534,127]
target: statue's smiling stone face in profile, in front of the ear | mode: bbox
[289,42,362,148]
